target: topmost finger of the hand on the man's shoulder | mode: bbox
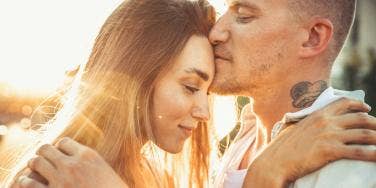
[323,98,371,115]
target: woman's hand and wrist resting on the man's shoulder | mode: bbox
[243,99,376,187]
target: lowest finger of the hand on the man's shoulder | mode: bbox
[337,145,376,162]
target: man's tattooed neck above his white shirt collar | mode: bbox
[252,71,329,148]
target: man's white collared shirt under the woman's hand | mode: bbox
[214,87,376,188]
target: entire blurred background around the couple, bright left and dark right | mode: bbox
[0,0,376,156]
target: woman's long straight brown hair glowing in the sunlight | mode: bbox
[0,0,215,187]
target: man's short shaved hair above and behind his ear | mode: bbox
[288,0,356,61]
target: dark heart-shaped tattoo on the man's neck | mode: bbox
[290,80,328,108]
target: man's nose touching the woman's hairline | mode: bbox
[209,17,229,45]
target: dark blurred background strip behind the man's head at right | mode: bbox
[332,0,376,116]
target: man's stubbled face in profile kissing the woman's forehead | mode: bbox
[209,0,299,96]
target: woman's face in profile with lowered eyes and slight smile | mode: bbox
[152,36,214,153]
